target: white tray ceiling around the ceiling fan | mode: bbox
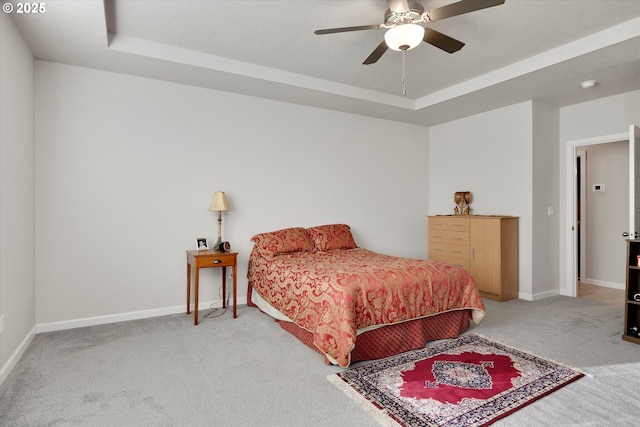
[10,0,640,126]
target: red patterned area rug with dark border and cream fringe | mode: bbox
[328,334,583,427]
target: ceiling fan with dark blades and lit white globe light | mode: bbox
[315,0,504,65]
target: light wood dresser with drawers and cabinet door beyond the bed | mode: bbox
[428,215,518,301]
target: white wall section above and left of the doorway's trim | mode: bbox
[558,90,640,295]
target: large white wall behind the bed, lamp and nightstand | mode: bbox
[36,61,428,329]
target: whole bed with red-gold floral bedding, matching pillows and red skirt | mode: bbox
[247,224,484,367]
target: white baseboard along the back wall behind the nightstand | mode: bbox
[36,297,247,334]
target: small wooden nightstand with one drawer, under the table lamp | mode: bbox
[187,250,238,325]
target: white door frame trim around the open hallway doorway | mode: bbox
[560,132,630,297]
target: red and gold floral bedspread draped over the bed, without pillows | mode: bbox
[248,247,484,367]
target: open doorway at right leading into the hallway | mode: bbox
[574,140,629,309]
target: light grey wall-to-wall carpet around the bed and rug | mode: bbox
[0,297,640,426]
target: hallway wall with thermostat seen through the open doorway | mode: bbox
[583,141,629,289]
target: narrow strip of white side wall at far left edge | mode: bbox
[0,14,35,383]
